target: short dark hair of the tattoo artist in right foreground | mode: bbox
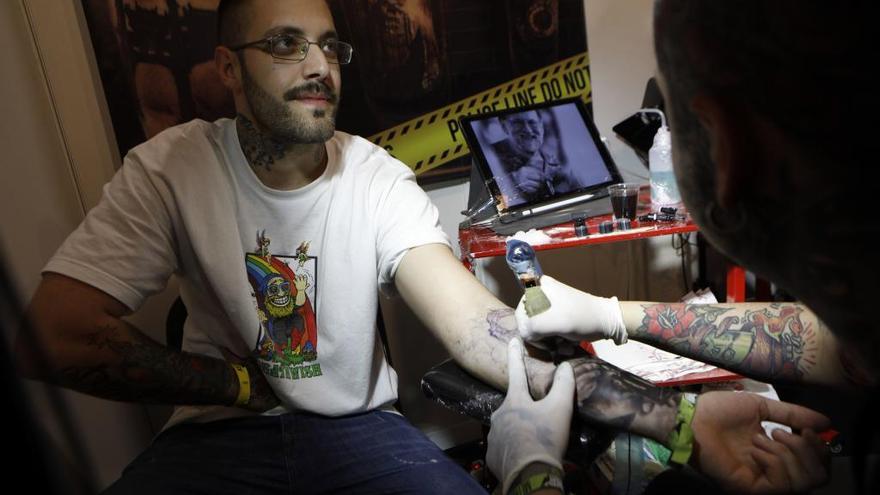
[655,0,878,152]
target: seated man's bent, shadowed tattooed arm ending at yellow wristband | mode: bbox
[15,273,278,411]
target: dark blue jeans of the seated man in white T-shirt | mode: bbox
[104,411,486,495]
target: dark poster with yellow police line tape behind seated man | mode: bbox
[82,0,591,184]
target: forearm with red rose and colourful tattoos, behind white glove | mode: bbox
[630,304,818,381]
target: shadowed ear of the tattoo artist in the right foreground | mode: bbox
[691,94,757,209]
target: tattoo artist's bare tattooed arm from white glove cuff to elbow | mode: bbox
[620,302,864,386]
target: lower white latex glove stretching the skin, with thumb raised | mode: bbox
[486,338,574,493]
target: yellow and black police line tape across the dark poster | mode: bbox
[369,52,592,175]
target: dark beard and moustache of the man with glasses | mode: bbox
[241,64,338,144]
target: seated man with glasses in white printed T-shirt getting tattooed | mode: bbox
[16,0,821,493]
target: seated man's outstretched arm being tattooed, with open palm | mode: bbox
[395,252,828,493]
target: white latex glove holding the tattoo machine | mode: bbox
[515,275,627,345]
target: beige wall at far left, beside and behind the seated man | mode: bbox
[0,0,180,487]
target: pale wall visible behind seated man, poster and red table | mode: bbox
[0,0,684,486]
